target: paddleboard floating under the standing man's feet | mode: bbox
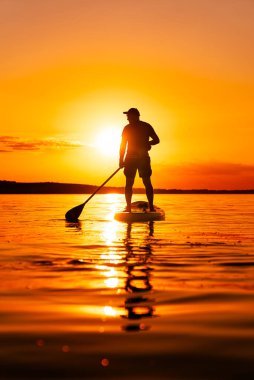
[115,201,165,222]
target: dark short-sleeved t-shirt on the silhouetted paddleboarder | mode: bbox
[122,120,156,157]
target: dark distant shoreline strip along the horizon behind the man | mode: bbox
[0,181,254,194]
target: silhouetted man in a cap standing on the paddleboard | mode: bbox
[119,108,160,212]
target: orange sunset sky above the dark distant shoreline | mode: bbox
[0,0,254,189]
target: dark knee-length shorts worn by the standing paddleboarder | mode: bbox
[124,156,152,178]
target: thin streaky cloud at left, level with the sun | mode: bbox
[0,136,84,153]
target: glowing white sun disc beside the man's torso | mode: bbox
[94,127,121,157]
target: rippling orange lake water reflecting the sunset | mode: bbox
[0,194,254,379]
